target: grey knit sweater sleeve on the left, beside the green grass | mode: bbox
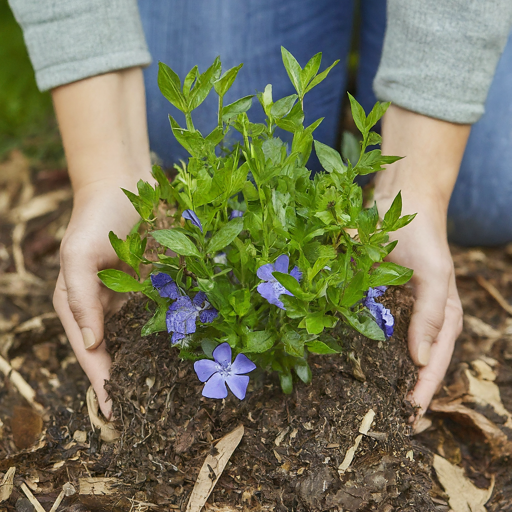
[9,0,151,91]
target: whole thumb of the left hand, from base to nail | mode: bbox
[62,246,104,350]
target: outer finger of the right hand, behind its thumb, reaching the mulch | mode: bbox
[412,276,462,415]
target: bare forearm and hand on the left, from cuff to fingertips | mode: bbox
[52,68,153,418]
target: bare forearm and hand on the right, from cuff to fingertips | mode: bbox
[375,105,470,417]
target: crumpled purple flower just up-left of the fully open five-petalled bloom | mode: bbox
[165,292,219,343]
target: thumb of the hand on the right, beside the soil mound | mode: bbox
[409,266,452,366]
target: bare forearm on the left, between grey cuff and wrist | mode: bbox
[52,68,151,194]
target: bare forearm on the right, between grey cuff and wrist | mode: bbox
[376,105,470,230]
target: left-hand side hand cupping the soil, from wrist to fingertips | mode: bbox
[53,180,142,419]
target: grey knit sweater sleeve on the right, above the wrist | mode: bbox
[373,0,512,123]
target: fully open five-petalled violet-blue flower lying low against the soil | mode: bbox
[194,343,256,400]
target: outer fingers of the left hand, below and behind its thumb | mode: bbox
[53,272,112,419]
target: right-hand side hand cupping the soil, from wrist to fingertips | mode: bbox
[376,188,463,416]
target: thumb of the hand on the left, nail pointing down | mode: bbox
[66,270,104,350]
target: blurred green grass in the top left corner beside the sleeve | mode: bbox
[0,0,65,168]
